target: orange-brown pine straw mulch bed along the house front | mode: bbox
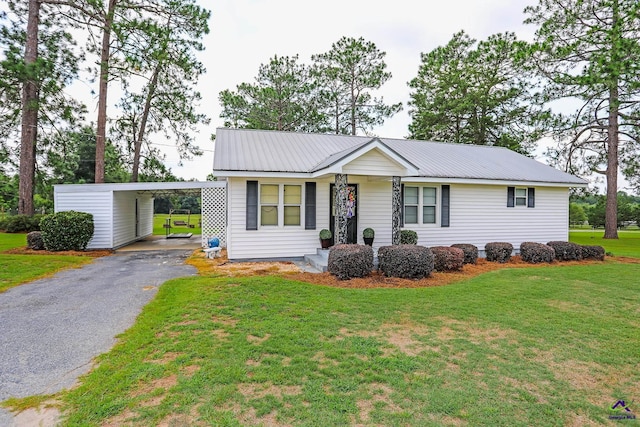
[186,249,640,289]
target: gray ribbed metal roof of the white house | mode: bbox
[213,128,587,185]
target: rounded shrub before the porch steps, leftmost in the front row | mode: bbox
[327,244,373,280]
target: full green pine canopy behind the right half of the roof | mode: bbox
[409,31,551,154]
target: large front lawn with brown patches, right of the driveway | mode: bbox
[63,261,640,426]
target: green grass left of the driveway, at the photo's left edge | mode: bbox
[0,233,91,293]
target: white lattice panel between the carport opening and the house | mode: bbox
[202,187,227,248]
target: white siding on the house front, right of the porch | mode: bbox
[404,183,569,250]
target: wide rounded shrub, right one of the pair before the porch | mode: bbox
[378,244,433,279]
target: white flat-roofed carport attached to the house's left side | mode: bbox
[53,181,227,249]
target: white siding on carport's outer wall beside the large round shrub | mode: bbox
[54,191,113,249]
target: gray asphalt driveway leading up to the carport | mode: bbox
[0,250,196,426]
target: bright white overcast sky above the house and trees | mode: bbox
[162,0,537,180]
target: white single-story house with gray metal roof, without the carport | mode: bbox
[213,128,587,260]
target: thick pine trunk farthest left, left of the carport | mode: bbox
[18,0,40,215]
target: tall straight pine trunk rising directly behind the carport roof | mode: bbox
[95,0,117,183]
